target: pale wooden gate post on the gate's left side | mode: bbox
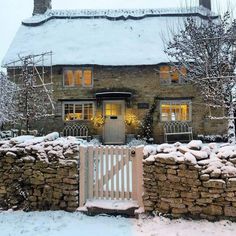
[79,146,88,207]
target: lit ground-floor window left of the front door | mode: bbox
[63,102,94,121]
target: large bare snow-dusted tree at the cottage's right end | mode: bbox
[165,12,236,143]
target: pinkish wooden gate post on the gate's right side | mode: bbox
[132,146,144,207]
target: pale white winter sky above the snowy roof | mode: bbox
[0,0,236,70]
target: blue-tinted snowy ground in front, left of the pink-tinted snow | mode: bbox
[0,211,133,236]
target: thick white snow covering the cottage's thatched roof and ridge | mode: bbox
[2,7,218,66]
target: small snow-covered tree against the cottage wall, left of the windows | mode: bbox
[17,56,54,134]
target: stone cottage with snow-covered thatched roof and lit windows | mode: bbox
[3,0,226,144]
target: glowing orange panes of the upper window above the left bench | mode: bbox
[64,69,93,87]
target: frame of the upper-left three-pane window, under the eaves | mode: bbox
[63,67,94,88]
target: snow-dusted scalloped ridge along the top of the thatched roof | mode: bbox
[22,6,217,26]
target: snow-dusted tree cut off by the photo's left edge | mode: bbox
[0,72,18,129]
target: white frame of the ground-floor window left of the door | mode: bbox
[62,101,95,122]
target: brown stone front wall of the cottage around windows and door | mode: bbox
[20,65,226,142]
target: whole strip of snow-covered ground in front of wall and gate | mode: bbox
[0,211,236,236]
